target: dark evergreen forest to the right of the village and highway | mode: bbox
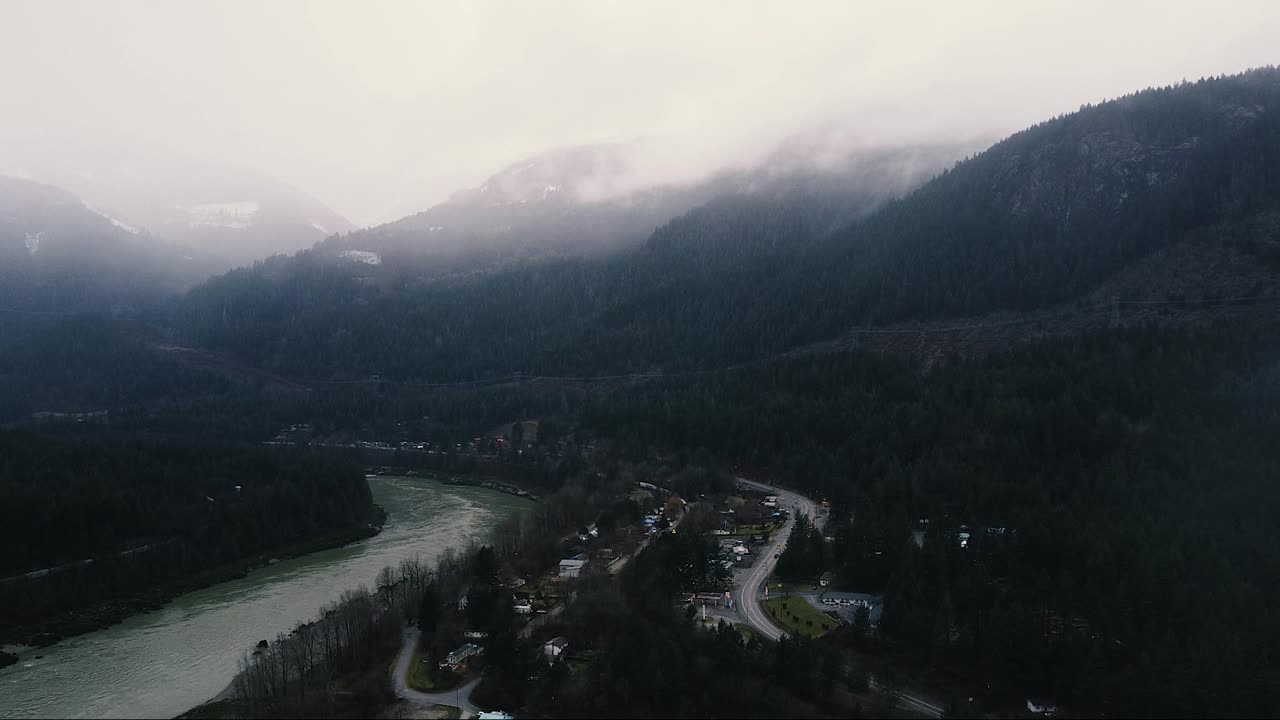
[586,325,1280,715]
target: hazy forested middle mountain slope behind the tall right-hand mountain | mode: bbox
[174,146,956,379]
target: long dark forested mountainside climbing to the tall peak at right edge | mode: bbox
[175,68,1280,379]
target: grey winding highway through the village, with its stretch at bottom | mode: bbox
[737,478,943,717]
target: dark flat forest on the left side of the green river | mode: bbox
[0,433,379,639]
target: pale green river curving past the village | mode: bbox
[0,477,530,717]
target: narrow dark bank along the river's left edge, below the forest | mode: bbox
[0,505,387,650]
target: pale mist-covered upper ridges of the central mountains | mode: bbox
[321,135,974,273]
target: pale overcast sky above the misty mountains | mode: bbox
[0,0,1280,224]
